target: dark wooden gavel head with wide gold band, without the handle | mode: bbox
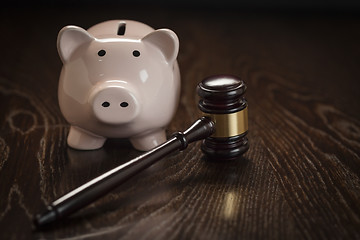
[197,75,249,160]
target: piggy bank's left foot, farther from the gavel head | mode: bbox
[67,126,106,150]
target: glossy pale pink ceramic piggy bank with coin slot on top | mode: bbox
[57,20,180,151]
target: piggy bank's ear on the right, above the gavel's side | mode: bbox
[142,29,179,63]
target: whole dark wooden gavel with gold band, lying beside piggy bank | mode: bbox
[34,75,249,229]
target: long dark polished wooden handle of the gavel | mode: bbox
[34,117,215,228]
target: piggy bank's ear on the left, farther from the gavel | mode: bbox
[57,26,95,63]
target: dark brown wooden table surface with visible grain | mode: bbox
[0,6,360,239]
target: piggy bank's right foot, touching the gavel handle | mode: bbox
[130,129,166,151]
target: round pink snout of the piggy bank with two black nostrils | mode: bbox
[90,84,140,124]
